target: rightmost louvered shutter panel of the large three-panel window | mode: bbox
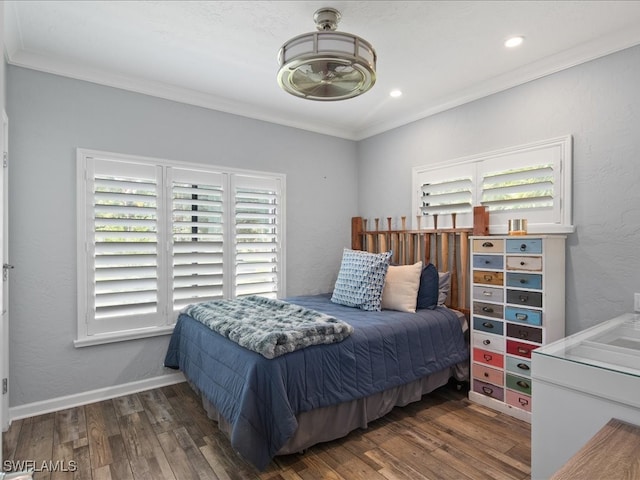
[232,175,283,298]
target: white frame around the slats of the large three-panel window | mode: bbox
[74,148,286,347]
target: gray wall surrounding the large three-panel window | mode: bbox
[7,66,357,406]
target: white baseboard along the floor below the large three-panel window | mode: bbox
[9,372,186,424]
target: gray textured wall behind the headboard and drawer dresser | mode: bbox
[358,47,640,334]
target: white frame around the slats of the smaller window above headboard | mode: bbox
[411,135,575,235]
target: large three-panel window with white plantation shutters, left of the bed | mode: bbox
[75,149,284,346]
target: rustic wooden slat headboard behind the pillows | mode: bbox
[351,214,473,318]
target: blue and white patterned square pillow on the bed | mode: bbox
[331,248,391,312]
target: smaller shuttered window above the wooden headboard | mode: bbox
[413,136,573,234]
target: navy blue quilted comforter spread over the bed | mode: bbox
[165,295,469,470]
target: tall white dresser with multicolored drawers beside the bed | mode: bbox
[469,235,566,422]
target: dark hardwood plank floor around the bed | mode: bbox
[3,383,531,480]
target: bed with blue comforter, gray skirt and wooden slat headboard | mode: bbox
[165,217,469,470]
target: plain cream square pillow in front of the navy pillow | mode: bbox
[381,262,422,313]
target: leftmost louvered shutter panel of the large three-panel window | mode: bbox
[87,158,162,334]
